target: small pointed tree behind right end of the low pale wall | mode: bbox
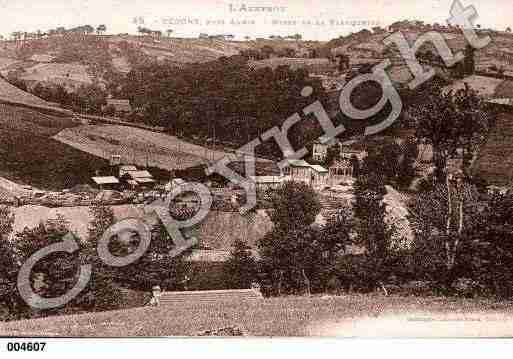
[223,239,257,289]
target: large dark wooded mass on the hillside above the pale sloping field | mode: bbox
[120,56,325,158]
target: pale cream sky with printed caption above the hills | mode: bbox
[0,0,513,40]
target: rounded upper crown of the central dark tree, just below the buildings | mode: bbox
[271,181,321,232]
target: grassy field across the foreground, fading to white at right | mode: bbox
[0,295,513,337]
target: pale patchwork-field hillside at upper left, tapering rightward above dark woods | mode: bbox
[0,34,317,89]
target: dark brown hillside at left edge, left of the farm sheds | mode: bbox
[0,103,108,189]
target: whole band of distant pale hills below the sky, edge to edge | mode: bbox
[0,26,513,93]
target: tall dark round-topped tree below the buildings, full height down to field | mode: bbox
[258,182,332,295]
